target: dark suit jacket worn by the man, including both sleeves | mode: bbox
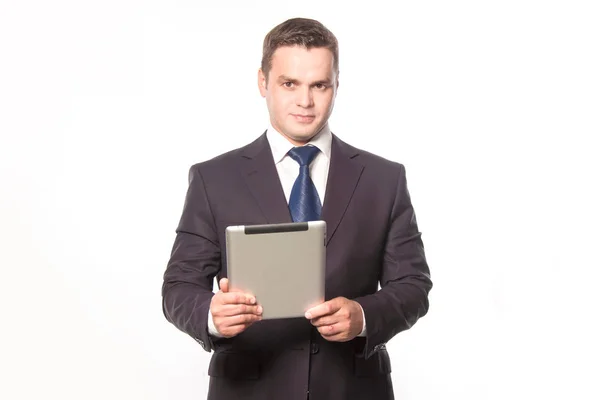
[162,134,432,400]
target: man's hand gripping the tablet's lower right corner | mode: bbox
[305,297,363,342]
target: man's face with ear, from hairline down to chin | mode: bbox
[258,46,338,146]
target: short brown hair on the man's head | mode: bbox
[261,18,339,80]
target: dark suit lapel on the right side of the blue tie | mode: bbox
[322,135,364,243]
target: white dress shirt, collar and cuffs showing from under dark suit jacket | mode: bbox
[208,124,367,337]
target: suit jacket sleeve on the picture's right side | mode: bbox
[355,165,432,358]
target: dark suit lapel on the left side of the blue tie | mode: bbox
[241,132,292,224]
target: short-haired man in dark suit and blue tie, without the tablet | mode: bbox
[162,18,432,400]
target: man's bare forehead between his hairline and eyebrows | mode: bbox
[269,46,335,79]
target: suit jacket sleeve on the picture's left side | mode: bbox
[162,165,221,352]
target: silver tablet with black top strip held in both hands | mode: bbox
[225,221,326,319]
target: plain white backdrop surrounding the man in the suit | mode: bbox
[0,0,600,400]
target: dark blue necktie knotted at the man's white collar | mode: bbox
[288,146,321,222]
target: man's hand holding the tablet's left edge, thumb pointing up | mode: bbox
[210,278,262,338]
